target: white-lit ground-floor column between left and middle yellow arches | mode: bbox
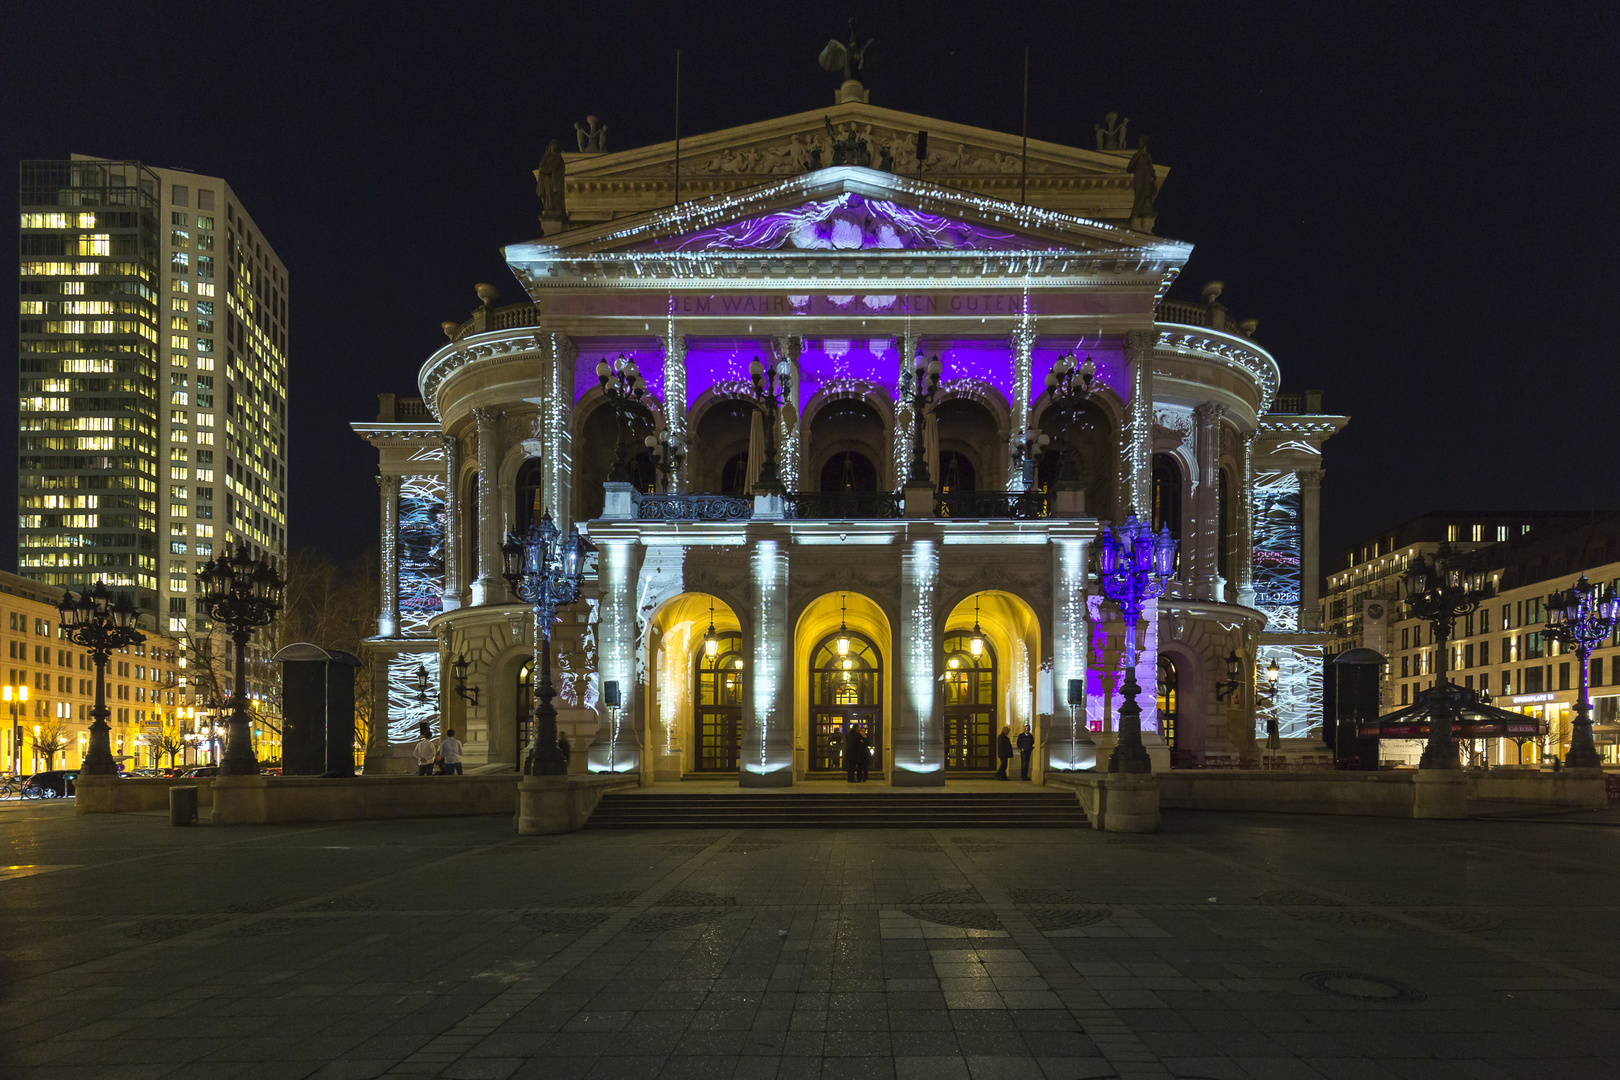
[737,529,794,787]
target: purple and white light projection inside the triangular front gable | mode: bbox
[638,191,1050,251]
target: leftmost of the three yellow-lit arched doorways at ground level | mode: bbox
[638,593,748,780]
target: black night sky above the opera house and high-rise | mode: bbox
[0,0,1620,582]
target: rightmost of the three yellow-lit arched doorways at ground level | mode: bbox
[940,589,1042,779]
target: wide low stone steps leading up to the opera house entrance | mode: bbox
[585,789,1087,829]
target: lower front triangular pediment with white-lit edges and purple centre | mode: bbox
[507,165,1191,267]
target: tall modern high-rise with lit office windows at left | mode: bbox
[18,155,287,718]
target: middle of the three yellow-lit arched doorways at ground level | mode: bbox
[794,593,893,780]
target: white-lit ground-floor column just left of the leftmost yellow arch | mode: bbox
[592,538,642,772]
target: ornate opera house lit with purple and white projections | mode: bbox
[355,84,1345,785]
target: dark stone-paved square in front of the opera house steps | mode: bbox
[0,805,1620,1080]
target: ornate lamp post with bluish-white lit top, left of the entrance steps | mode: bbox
[501,510,591,776]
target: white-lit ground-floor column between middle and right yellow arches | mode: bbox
[889,526,944,787]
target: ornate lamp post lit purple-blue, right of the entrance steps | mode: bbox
[1097,513,1176,772]
